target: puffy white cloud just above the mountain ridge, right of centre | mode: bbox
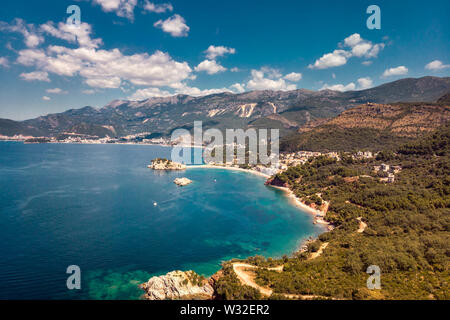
[247,68,297,91]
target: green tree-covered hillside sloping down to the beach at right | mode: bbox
[219,124,450,299]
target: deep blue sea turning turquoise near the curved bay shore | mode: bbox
[0,142,321,299]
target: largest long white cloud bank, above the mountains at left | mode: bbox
[17,46,192,88]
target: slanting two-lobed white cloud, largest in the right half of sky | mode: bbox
[308,33,385,69]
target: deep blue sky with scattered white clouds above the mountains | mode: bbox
[0,0,450,120]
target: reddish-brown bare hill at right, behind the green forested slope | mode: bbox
[280,99,450,152]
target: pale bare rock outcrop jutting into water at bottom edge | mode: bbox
[140,271,214,300]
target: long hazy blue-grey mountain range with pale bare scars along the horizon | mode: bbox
[0,77,450,137]
